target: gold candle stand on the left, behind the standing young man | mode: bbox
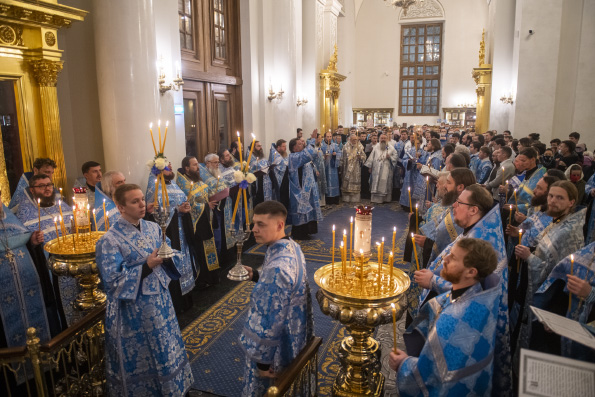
[44,226,105,311]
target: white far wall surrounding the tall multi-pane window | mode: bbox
[353,0,488,124]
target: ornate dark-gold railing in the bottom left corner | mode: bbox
[0,306,105,397]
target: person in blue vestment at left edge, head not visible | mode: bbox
[0,200,66,348]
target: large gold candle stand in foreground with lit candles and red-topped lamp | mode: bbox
[314,206,410,397]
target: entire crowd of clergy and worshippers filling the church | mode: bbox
[0,125,595,395]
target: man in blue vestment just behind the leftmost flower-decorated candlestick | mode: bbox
[145,164,198,313]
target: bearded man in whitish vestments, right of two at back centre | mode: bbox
[365,134,398,203]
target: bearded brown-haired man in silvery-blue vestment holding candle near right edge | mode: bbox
[510,180,586,354]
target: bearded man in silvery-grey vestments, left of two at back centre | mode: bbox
[341,134,366,203]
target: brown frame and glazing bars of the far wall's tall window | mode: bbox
[397,21,444,116]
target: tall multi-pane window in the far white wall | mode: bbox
[399,23,442,116]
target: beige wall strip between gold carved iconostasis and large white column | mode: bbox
[57,0,105,188]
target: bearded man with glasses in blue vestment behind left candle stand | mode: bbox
[17,174,80,325]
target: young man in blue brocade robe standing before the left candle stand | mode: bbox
[96,184,193,397]
